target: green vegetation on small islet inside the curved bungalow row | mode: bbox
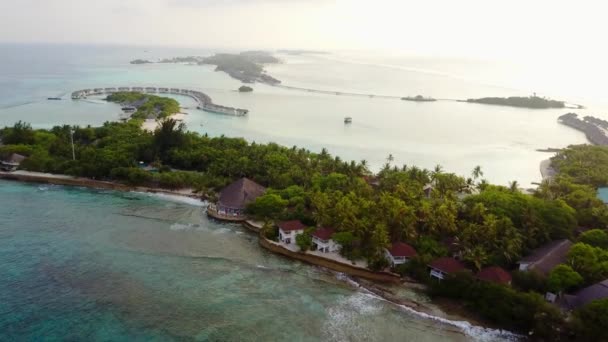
[106,92,180,119]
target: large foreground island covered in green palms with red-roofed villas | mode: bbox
[0,118,608,341]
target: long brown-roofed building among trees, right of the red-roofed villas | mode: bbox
[518,240,572,275]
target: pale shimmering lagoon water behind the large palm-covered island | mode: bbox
[0,44,592,186]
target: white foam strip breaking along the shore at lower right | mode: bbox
[336,273,524,342]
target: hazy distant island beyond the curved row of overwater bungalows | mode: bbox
[131,51,281,85]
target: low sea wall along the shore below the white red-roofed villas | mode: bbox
[259,234,401,283]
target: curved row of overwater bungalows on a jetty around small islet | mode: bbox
[72,87,249,116]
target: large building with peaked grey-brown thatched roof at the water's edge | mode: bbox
[207,178,266,221]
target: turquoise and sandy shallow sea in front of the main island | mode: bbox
[0,181,516,341]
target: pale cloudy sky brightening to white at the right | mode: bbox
[0,0,608,58]
